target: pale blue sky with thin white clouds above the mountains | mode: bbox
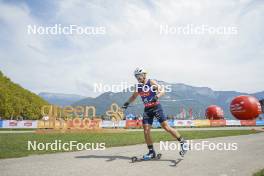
[0,0,264,97]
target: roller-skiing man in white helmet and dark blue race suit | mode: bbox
[123,68,187,160]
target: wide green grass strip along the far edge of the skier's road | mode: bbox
[0,130,257,158]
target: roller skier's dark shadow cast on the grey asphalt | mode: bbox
[75,155,183,167]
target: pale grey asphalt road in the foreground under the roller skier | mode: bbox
[0,133,264,176]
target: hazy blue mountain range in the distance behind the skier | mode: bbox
[39,81,264,119]
